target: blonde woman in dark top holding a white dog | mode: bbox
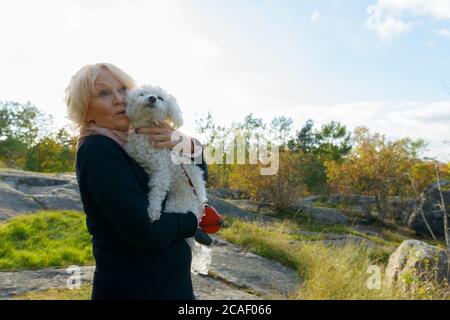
[65,63,207,300]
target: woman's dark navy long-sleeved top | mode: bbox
[76,135,208,300]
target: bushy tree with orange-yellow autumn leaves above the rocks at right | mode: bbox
[326,127,431,221]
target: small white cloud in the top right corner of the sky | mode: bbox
[367,0,450,41]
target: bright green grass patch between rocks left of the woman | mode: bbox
[0,210,94,271]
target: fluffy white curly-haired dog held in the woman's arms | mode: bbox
[125,85,211,274]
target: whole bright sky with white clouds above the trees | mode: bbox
[0,0,450,161]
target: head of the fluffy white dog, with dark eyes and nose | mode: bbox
[126,85,183,129]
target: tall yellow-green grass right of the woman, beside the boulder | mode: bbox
[219,217,448,300]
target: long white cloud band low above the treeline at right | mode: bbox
[278,101,450,161]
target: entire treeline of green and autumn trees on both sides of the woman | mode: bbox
[0,102,450,225]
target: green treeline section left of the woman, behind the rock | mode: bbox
[0,101,76,172]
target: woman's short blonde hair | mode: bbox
[64,63,137,129]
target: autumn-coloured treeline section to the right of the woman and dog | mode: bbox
[197,114,450,221]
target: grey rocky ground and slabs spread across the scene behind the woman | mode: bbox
[0,170,450,300]
